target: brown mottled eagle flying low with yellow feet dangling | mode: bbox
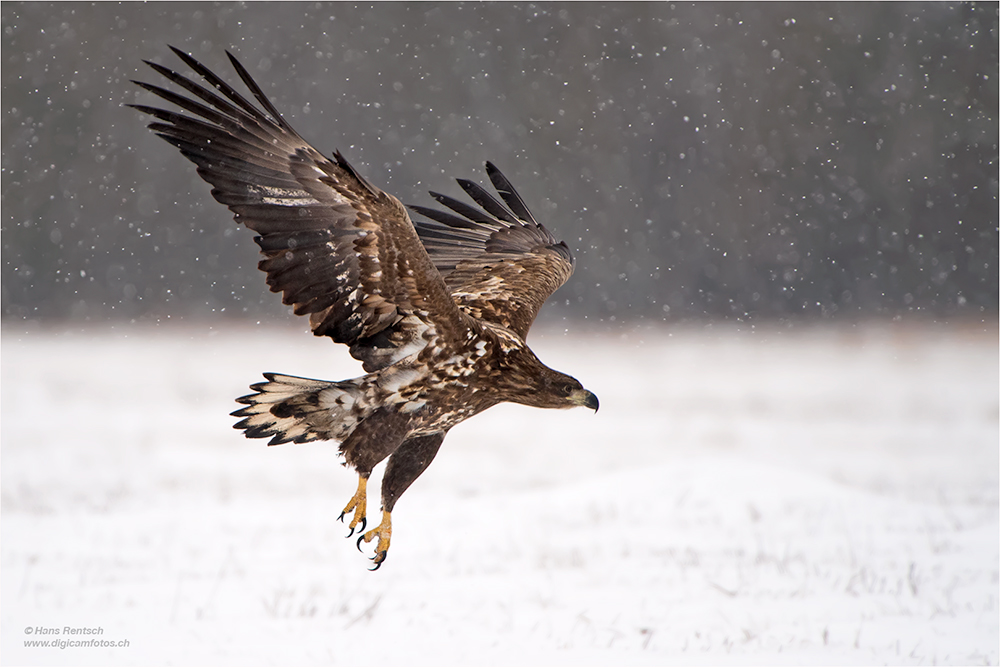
[128,46,599,570]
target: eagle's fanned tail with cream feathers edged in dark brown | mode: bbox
[232,373,363,445]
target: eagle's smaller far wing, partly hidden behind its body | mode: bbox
[410,162,573,338]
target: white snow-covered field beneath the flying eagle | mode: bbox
[0,324,1000,665]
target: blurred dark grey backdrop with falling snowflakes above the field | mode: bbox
[0,2,998,322]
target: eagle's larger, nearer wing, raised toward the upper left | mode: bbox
[129,47,468,370]
